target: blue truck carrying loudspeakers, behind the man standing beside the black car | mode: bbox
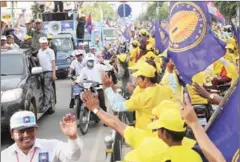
[52,33,75,78]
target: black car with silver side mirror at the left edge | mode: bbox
[1,49,56,131]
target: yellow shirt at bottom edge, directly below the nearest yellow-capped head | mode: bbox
[160,146,203,162]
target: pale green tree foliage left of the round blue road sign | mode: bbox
[81,2,117,21]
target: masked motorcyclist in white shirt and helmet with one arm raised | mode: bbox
[75,54,112,111]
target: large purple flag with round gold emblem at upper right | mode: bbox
[168,2,226,84]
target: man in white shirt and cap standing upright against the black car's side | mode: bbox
[37,37,56,112]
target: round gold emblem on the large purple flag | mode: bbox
[169,2,207,52]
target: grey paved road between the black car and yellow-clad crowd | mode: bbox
[1,80,110,162]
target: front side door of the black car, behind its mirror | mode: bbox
[29,57,43,111]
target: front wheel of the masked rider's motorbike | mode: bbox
[79,107,91,135]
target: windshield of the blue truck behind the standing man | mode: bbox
[52,38,73,51]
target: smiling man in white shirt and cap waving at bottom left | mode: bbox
[1,111,83,162]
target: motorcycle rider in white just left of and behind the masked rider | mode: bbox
[68,50,85,108]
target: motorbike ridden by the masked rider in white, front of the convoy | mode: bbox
[72,78,101,135]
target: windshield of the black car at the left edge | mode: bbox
[1,54,24,76]
